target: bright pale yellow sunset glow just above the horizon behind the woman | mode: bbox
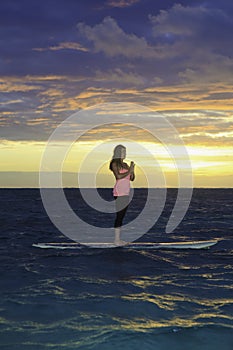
[0,140,233,187]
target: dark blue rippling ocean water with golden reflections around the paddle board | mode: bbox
[0,189,233,350]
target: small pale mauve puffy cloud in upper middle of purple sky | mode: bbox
[77,17,156,59]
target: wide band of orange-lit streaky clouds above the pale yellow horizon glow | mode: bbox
[0,72,233,145]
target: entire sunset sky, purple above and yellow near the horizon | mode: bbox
[0,0,233,187]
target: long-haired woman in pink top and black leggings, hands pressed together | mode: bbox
[109,145,135,245]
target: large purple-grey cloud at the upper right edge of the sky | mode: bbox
[149,4,233,82]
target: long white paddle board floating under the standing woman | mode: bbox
[33,240,218,249]
